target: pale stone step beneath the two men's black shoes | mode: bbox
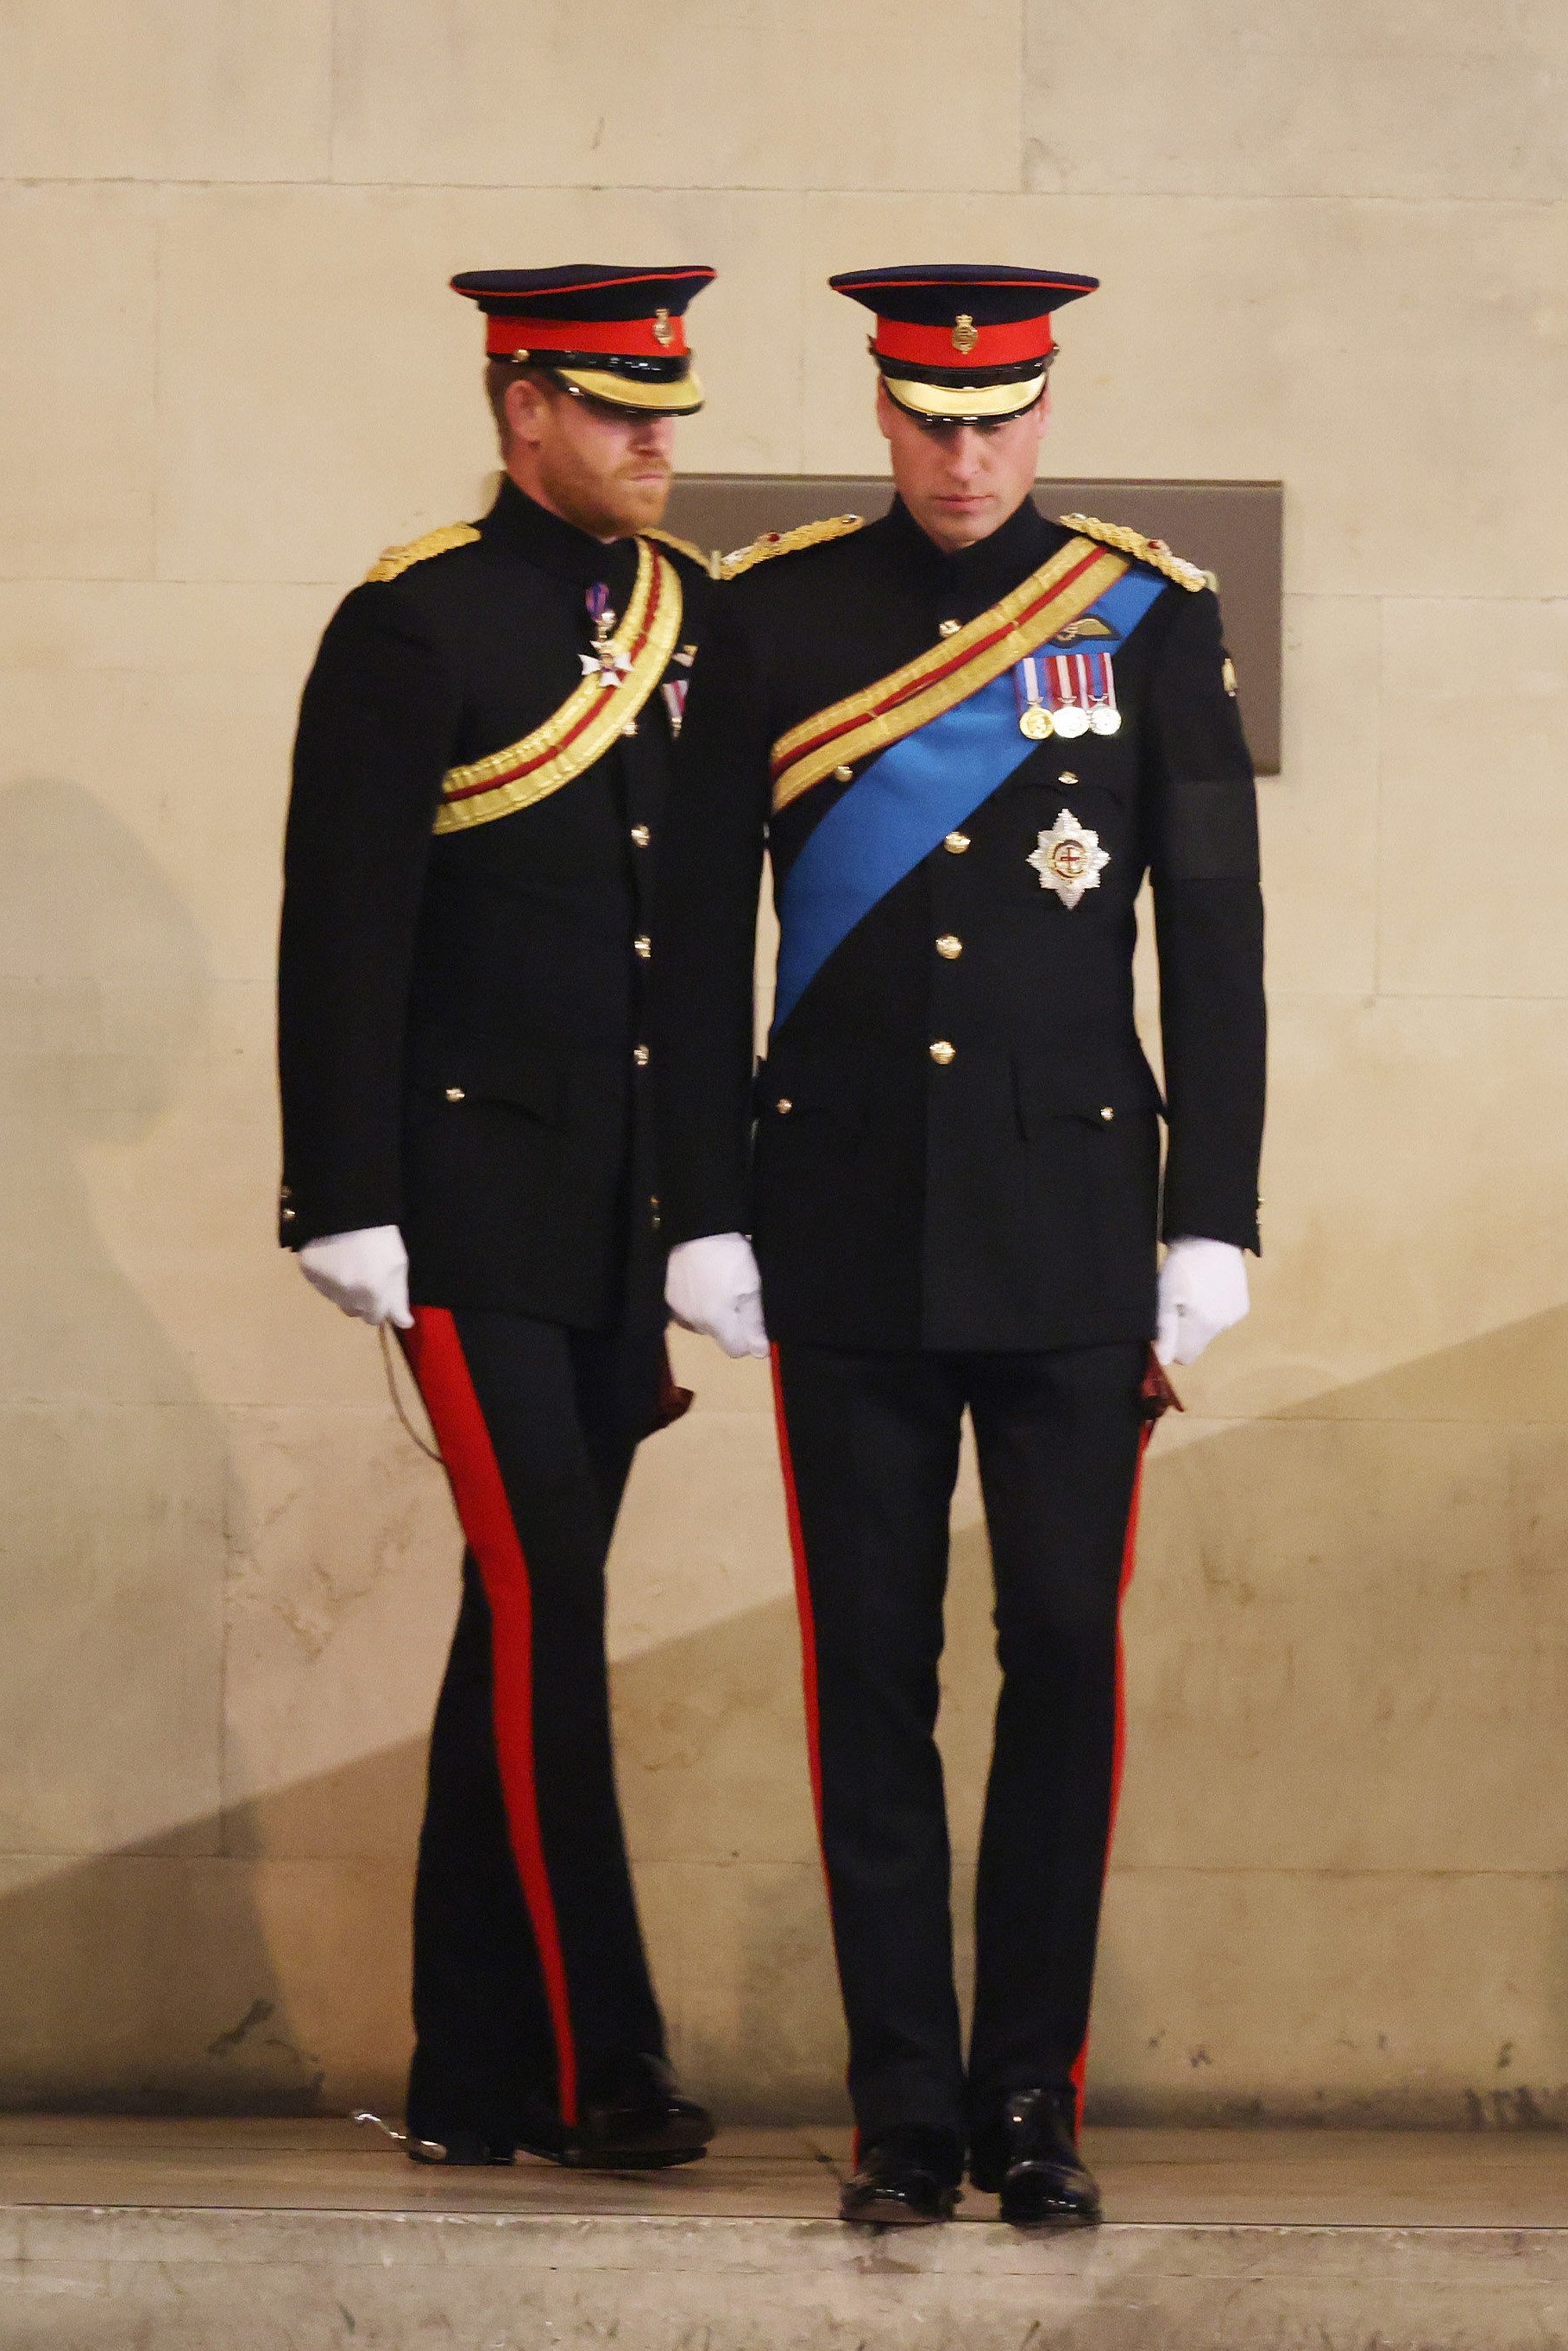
[0,2118,1568,2351]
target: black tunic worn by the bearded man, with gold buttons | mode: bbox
[277,480,708,1328]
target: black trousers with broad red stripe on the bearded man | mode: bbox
[406,1308,665,2146]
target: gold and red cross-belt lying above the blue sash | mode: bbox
[771,539,1130,814]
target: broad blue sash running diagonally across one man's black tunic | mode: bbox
[773,571,1166,1035]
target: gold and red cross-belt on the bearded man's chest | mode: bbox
[435,539,682,832]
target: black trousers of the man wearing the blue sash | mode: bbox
[776,1345,1147,2140]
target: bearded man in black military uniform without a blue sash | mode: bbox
[280,268,712,2165]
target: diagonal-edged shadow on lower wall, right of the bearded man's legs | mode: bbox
[616,1309,1568,2127]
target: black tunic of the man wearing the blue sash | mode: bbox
[653,486,1265,1350]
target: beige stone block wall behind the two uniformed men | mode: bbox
[0,0,1568,2118]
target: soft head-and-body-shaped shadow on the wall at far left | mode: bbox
[0,780,310,2102]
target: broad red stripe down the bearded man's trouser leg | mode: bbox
[405,1308,578,2125]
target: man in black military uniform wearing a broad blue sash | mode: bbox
[653,268,1265,2222]
